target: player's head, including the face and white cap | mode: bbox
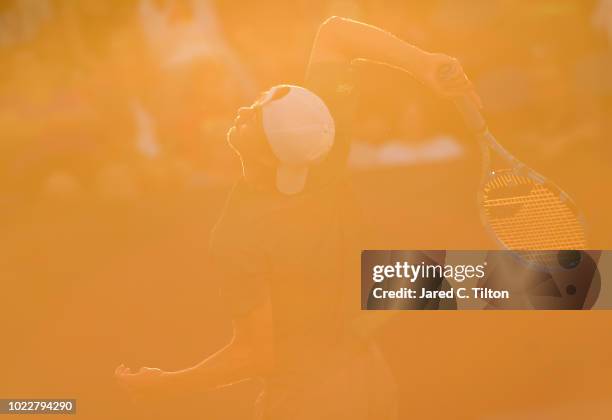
[228,85,335,194]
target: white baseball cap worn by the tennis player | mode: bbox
[259,85,335,194]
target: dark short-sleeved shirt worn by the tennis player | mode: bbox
[211,60,360,382]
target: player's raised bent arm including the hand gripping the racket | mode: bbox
[309,16,480,104]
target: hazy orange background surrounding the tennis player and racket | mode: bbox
[0,0,612,419]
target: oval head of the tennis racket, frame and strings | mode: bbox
[478,158,587,269]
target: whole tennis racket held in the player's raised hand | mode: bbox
[440,67,587,266]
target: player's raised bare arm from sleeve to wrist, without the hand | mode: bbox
[311,16,429,76]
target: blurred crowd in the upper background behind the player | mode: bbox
[0,0,612,200]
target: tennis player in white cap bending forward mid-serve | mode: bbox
[115,17,478,420]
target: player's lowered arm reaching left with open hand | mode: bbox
[115,299,274,393]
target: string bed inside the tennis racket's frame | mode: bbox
[482,174,586,260]
